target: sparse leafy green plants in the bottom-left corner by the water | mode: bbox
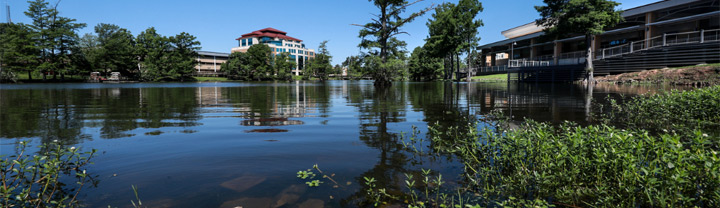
[0,142,96,207]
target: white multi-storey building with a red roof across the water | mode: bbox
[232,28,315,75]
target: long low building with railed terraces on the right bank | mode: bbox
[478,0,720,74]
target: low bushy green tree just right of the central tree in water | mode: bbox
[408,47,443,81]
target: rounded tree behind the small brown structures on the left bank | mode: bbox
[94,23,137,76]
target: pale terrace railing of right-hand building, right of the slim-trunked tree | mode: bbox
[595,29,720,59]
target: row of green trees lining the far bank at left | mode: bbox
[0,0,200,81]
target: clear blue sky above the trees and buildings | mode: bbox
[0,0,659,65]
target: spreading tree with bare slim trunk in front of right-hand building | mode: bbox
[535,0,623,84]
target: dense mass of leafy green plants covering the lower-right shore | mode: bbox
[299,87,720,207]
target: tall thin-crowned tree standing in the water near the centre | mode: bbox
[357,0,433,87]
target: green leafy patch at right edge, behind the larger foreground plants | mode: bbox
[602,86,720,133]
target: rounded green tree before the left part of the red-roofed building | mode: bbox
[247,44,272,81]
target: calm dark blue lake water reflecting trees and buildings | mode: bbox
[0,81,692,208]
